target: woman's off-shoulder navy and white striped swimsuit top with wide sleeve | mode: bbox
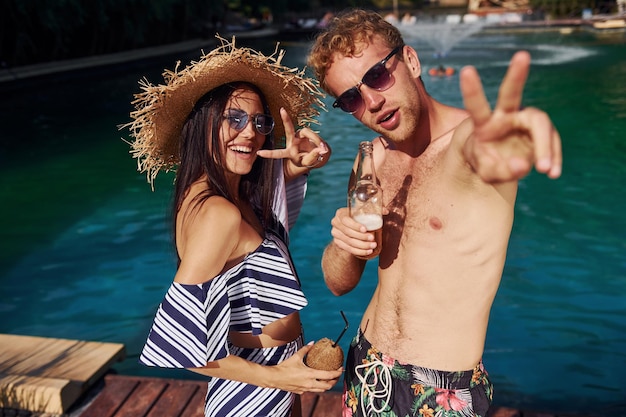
[139,233,307,368]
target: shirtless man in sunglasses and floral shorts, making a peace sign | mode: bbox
[308,10,562,417]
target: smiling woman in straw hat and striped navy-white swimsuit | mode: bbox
[129,36,341,417]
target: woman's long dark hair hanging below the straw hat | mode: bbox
[173,82,274,261]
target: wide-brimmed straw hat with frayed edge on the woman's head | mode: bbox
[121,36,324,185]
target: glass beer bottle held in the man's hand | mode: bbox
[348,141,383,259]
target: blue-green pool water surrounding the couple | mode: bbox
[0,32,626,416]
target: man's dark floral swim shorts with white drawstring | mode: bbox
[343,329,493,417]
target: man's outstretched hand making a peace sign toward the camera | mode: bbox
[460,51,563,183]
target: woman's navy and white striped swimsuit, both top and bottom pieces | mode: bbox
[139,235,307,417]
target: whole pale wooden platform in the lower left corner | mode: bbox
[0,334,125,415]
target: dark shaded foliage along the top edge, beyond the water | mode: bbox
[0,0,615,68]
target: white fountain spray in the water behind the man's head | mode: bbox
[394,15,485,57]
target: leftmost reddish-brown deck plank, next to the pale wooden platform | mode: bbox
[80,375,139,417]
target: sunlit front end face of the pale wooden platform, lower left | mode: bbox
[0,375,82,414]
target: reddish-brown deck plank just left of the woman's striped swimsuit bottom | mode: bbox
[147,380,206,417]
